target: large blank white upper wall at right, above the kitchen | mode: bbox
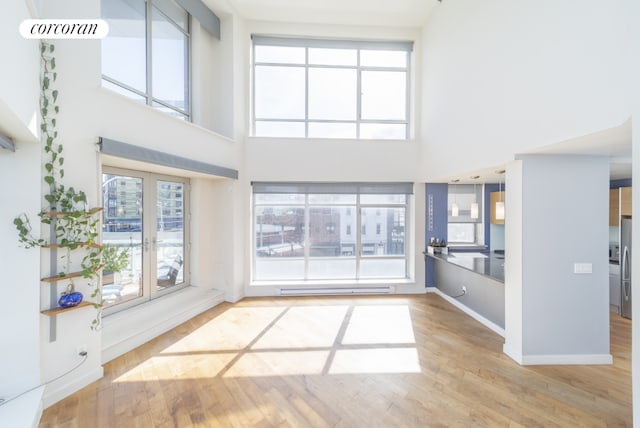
[421,0,629,179]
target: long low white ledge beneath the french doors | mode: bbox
[102,287,224,364]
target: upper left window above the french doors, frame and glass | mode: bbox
[101,0,191,120]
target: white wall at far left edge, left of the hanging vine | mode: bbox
[0,1,41,417]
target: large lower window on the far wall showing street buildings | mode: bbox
[253,183,412,280]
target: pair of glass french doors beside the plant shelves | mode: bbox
[102,167,189,313]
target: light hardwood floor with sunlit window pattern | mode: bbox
[40,294,632,428]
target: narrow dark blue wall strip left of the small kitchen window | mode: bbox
[425,183,449,287]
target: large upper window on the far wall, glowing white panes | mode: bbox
[252,35,413,139]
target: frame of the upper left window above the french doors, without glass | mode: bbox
[102,0,193,121]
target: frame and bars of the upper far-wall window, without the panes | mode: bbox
[251,34,413,140]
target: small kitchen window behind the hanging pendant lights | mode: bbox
[447,184,482,244]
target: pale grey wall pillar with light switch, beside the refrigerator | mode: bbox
[505,155,611,364]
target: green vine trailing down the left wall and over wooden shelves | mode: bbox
[13,41,102,329]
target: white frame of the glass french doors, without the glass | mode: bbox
[101,166,191,315]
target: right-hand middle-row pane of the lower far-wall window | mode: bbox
[360,207,405,256]
